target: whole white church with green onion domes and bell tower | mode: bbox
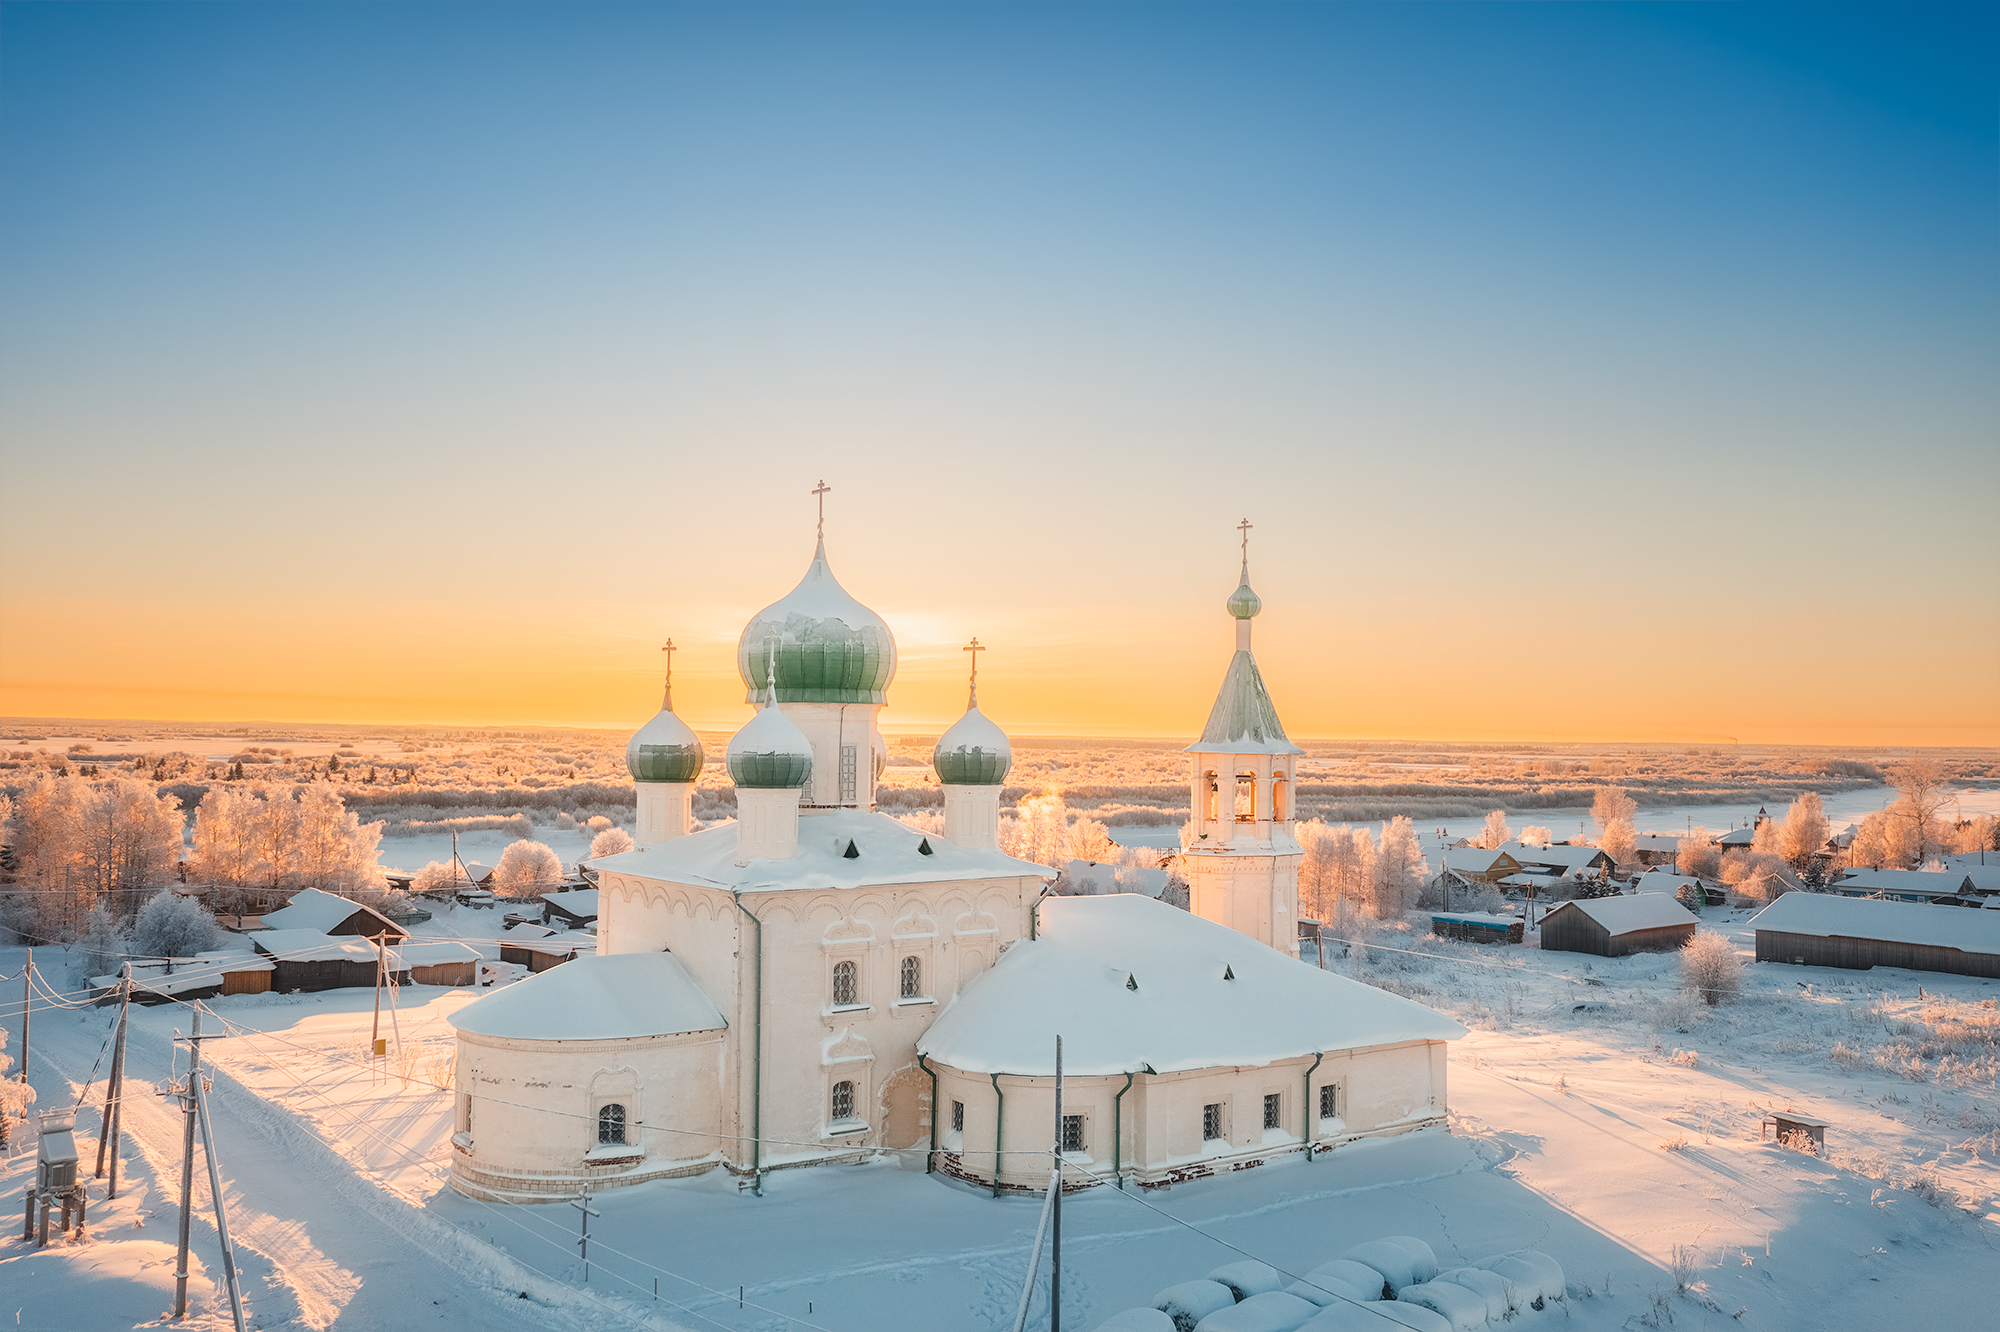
[450,508,1464,1202]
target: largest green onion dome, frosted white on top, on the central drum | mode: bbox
[736,540,896,704]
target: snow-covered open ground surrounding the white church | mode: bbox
[0,908,2000,1332]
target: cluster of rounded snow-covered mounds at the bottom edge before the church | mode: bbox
[1098,1234,1564,1332]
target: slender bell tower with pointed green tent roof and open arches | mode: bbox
[1184,518,1304,958]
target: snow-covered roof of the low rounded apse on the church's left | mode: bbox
[448,952,728,1040]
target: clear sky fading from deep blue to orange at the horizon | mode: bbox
[0,4,2000,742]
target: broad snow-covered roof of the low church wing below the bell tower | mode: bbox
[916,894,1466,1076]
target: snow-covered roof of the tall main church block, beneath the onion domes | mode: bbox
[590,810,1056,892]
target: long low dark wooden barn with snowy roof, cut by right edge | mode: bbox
[1750,892,2000,980]
